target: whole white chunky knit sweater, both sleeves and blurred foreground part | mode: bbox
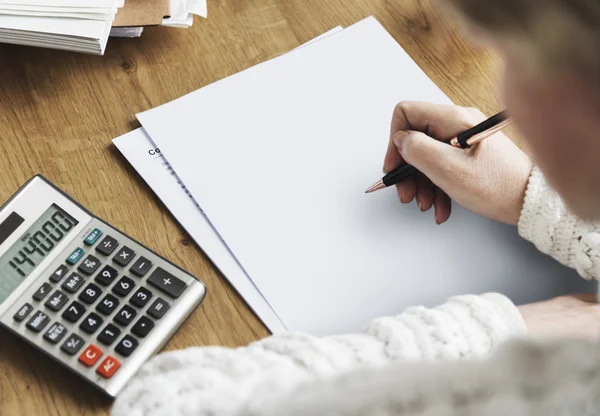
[113,169,600,416]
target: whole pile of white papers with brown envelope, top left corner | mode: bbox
[0,0,207,55]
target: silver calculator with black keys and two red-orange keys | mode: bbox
[0,175,206,397]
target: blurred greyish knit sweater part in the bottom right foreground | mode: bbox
[254,340,600,416]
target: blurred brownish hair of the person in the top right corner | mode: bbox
[448,0,600,73]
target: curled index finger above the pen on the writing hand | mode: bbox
[390,101,485,140]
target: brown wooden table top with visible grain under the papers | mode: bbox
[0,0,499,416]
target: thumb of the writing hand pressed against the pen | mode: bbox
[392,131,465,186]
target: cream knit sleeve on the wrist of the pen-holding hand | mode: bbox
[519,167,600,280]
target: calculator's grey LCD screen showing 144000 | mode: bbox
[0,204,79,304]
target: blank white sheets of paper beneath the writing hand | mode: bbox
[115,18,594,334]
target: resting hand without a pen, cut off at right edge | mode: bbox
[518,294,600,340]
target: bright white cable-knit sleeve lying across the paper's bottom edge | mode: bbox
[112,294,525,416]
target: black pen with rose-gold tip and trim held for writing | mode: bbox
[365,111,512,194]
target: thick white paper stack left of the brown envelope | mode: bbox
[0,0,124,54]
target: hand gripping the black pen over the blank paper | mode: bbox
[383,102,533,225]
